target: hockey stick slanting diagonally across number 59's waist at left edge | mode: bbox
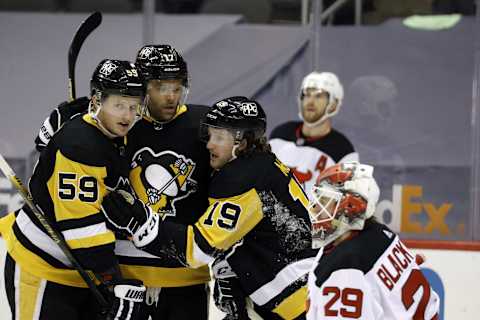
[0,154,109,310]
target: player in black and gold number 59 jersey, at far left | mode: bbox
[0,60,145,320]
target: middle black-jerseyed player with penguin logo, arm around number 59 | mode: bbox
[35,45,211,320]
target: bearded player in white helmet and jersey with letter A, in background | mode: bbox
[270,72,358,200]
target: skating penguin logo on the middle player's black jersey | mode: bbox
[130,147,197,216]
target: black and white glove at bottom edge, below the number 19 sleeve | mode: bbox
[212,260,249,320]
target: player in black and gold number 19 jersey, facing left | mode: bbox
[103,97,316,319]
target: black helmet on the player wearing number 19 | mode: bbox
[200,96,267,142]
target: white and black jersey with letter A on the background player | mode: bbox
[270,121,358,199]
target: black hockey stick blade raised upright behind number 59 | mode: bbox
[68,12,102,101]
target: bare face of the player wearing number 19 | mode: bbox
[207,127,235,169]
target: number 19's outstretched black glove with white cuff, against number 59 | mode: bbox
[102,190,160,248]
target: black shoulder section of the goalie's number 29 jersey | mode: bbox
[314,221,396,287]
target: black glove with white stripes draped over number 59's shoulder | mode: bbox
[35,97,90,151]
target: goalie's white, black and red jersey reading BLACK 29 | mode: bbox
[307,222,440,320]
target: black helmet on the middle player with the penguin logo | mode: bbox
[135,44,188,88]
